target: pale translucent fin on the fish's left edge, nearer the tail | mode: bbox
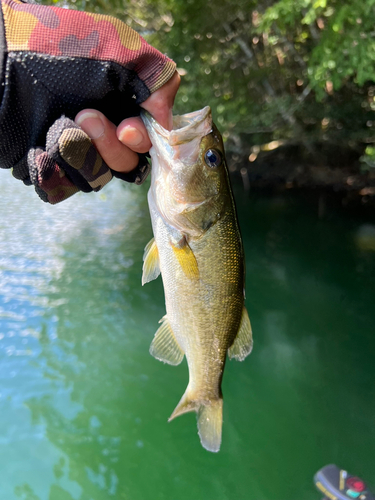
[150,316,184,366]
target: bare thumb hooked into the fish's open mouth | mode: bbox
[141,71,181,130]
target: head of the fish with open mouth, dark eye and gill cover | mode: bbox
[142,106,230,237]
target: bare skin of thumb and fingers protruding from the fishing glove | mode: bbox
[75,71,181,173]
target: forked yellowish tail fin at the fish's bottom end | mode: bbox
[168,390,223,452]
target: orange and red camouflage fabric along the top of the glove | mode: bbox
[2,0,175,92]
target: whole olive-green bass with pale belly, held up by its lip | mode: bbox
[141,106,253,452]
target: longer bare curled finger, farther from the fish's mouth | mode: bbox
[75,109,139,172]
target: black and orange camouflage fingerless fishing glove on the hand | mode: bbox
[0,0,175,203]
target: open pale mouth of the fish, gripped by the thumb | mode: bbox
[141,106,212,148]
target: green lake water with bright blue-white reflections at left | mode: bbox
[0,171,375,500]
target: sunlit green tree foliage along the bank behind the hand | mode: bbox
[42,0,375,164]
